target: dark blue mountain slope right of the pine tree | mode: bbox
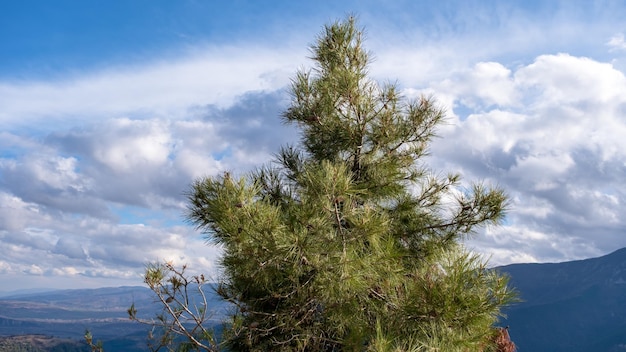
[497,248,626,352]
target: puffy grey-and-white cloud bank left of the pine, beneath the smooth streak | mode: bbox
[0,89,297,284]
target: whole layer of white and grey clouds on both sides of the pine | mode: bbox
[0,3,626,288]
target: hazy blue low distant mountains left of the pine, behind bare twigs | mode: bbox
[0,286,225,352]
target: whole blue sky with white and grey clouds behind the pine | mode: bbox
[0,0,626,291]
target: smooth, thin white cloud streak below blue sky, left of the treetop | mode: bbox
[0,47,305,129]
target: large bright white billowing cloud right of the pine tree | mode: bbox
[433,54,626,263]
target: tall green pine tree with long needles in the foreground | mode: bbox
[183,17,514,351]
